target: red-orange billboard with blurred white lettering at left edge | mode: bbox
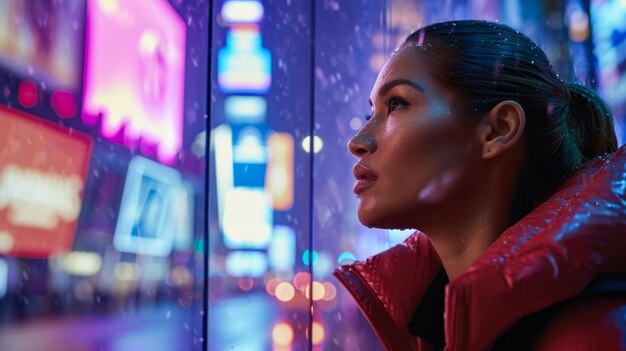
[0,107,92,257]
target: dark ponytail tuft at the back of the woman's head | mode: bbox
[567,83,617,162]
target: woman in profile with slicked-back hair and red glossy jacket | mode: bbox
[335,21,626,350]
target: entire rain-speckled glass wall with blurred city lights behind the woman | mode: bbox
[0,0,626,350]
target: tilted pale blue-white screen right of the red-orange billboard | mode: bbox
[113,156,180,256]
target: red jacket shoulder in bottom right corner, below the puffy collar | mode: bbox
[534,292,626,351]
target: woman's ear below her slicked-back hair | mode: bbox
[479,100,526,159]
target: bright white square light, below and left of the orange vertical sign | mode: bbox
[223,187,273,249]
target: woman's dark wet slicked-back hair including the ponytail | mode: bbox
[403,20,617,222]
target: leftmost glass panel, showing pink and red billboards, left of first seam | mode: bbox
[0,0,209,350]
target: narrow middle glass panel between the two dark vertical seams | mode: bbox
[208,0,314,350]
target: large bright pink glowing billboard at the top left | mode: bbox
[83,0,185,163]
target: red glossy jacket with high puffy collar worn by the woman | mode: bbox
[334,147,626,351]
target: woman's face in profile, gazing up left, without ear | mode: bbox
[348,45,482,231]
